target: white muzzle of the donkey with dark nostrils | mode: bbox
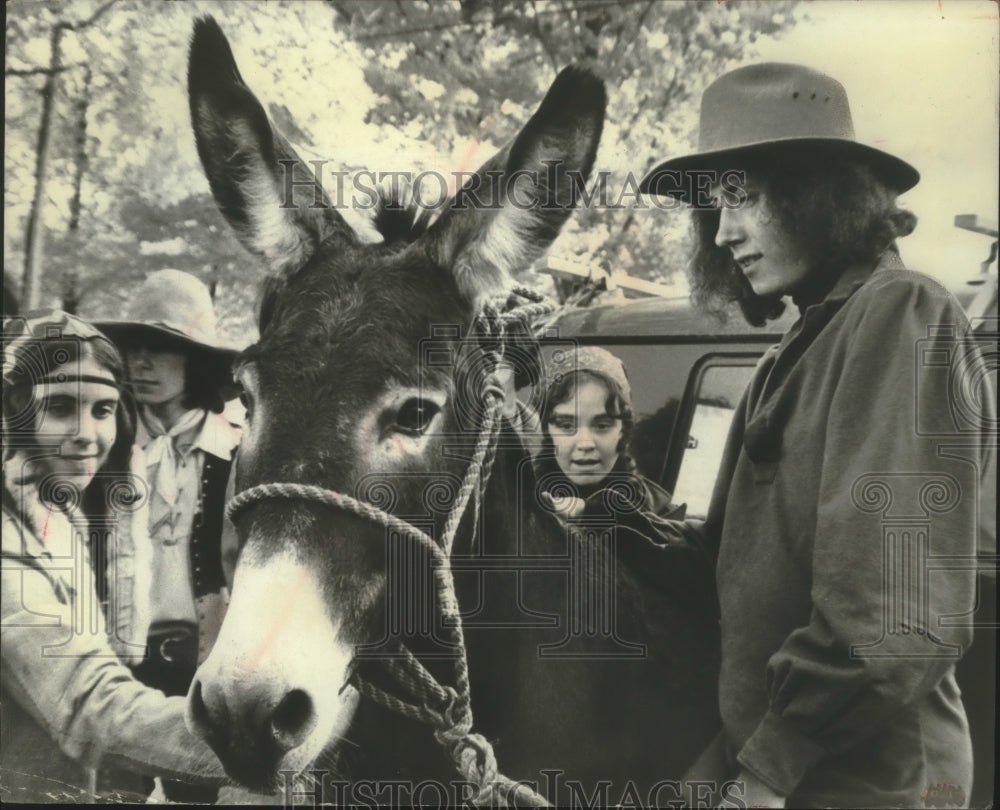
[187,553,353,774]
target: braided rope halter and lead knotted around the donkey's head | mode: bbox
[226,287,555,807]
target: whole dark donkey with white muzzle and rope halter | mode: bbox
[188,19,718,804]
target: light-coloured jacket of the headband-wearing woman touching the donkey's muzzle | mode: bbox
[0,448,223,802]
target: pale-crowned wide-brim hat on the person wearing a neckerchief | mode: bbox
[94,270,239,363]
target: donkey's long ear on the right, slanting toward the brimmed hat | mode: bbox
[425,68,607,304]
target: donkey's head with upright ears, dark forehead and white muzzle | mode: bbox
[182,20,605,787]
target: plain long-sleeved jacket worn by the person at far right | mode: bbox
[673,252,996,807]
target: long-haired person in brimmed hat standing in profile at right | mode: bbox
[641,64,996,807]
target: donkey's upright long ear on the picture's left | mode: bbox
[188,17,356,273]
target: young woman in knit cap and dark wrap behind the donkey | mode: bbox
[528,346,719,768]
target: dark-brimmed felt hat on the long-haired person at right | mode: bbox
[639,62,920,202]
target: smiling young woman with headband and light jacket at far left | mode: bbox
[0,311,223,802]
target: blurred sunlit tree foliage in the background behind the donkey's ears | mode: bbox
[4,0,792,340]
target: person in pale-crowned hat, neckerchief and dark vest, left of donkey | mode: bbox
[99,270,240,801]
